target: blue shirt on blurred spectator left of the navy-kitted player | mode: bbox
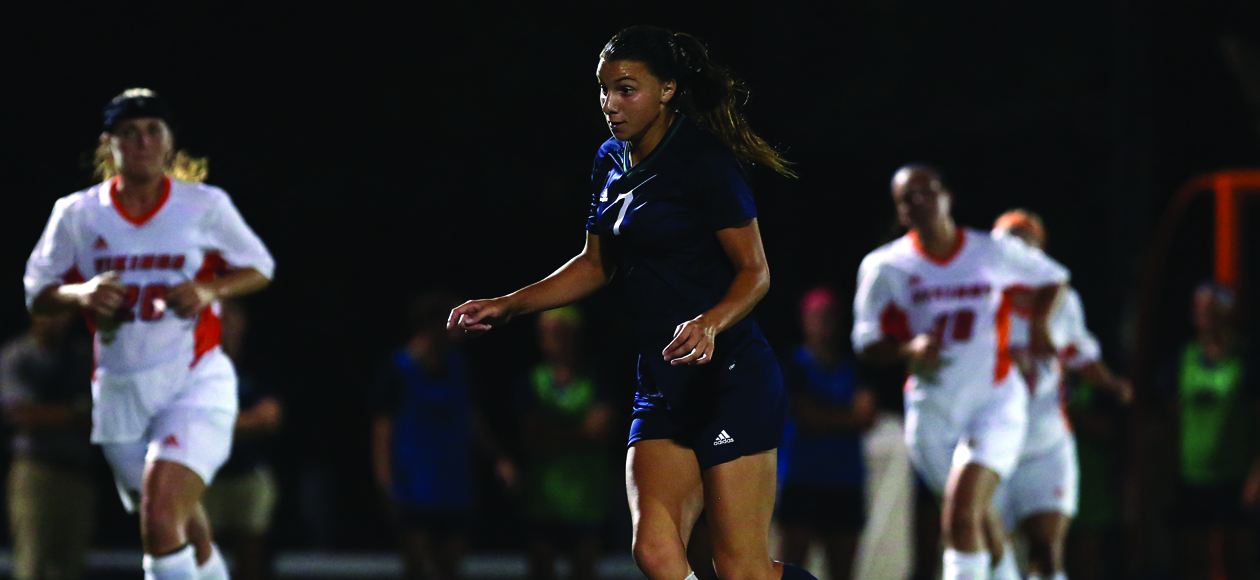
[377,349,474,512]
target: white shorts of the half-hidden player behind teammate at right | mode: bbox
[993,436,1080,530]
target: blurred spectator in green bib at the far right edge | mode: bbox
[1159,282,1260,579]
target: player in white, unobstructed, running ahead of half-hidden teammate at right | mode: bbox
[853,165,1067,580]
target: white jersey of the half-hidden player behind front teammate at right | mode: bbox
[1011,284,1101,456]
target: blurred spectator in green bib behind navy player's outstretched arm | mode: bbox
[520,306,617,580]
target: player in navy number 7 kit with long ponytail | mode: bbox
[449,26,808,580]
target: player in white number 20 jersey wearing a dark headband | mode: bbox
[24,88,275,580]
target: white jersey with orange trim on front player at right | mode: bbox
[853,228,1068,419]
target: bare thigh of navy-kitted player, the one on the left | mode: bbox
[626,439,703,543]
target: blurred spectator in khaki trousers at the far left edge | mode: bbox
[0,314,96,580]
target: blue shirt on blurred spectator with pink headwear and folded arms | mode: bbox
[779,345,866,489]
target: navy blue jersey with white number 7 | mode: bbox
[586,115,775,407]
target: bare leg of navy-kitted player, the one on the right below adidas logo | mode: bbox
[703,450,782,580]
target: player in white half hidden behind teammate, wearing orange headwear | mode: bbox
[993,209,1133,580]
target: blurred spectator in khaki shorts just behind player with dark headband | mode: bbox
[202,301,284,580]
